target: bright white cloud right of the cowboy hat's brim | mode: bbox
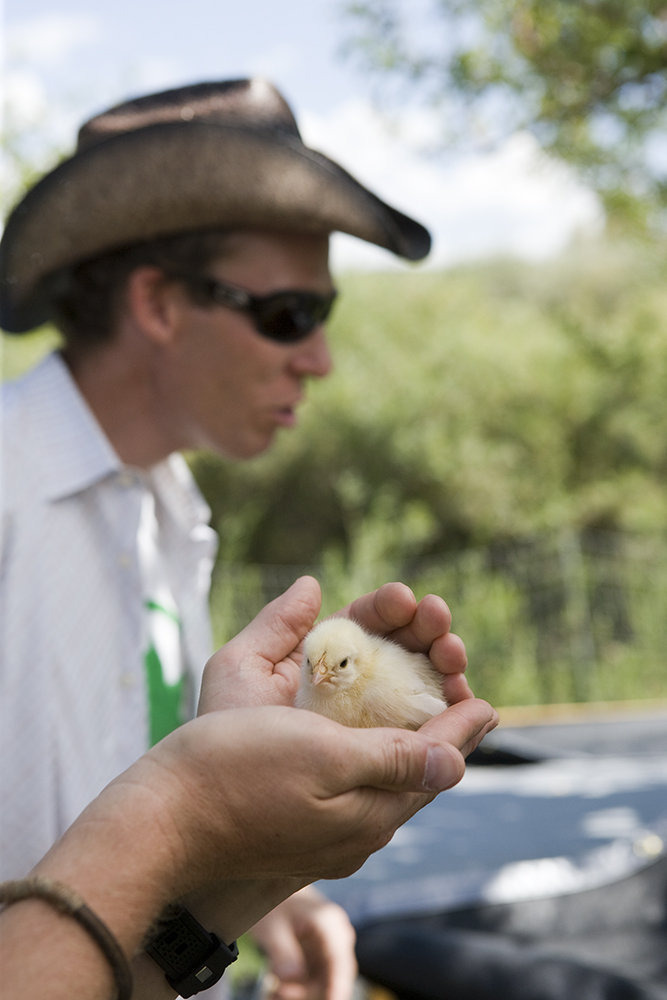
[301,101,600,268]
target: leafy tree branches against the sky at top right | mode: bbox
[342,0,667,225]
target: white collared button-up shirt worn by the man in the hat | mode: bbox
[0,354,217,879]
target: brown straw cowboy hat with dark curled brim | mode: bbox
[0,79,431,333]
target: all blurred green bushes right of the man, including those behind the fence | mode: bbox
[200,238,667,705]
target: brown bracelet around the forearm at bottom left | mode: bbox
[0,876,132,1000]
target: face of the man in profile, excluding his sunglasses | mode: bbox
[160,232,332,459]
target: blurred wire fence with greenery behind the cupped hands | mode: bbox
[213,530,667,705]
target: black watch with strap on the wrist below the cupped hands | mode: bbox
[144,906,239,997]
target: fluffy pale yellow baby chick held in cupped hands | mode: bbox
[295,618,447,729]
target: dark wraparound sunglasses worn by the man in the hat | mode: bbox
[166,271,337,344]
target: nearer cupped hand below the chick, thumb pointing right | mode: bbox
[133,699,497,895]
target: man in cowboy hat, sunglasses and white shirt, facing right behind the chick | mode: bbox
[0,74,468,997]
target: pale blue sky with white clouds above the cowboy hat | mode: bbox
[3,0,600,268]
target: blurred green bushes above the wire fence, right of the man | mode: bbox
[194,233,667,568]
